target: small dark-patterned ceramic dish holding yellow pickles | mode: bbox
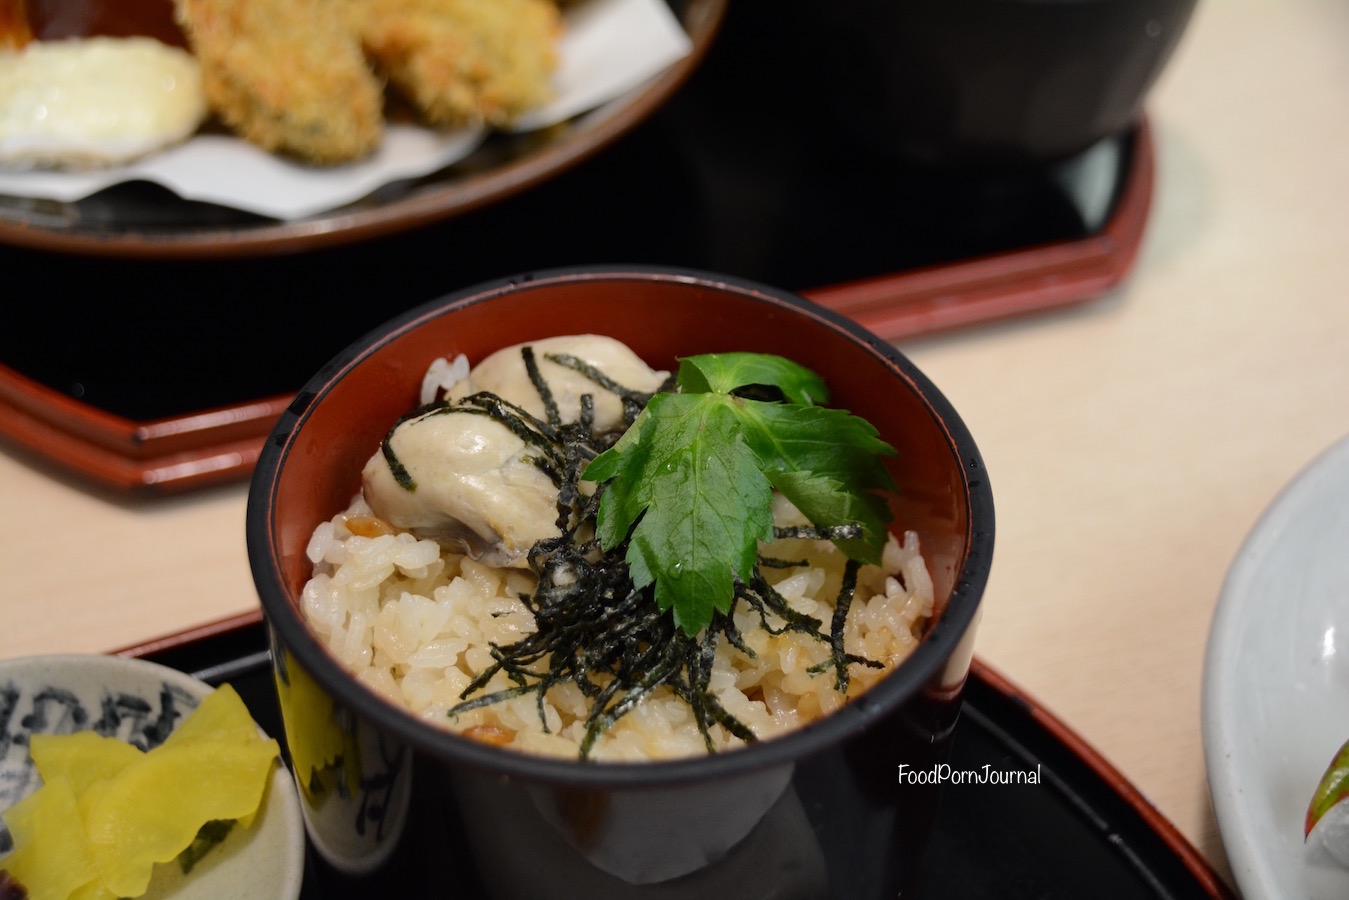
[0,654,305,900]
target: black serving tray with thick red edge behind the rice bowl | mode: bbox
[0,0,1153,494]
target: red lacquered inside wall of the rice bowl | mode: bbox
[272,273,970,631]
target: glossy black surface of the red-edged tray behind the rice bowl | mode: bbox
[0,0,1128,421]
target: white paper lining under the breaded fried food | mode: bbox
[0,0,692,219]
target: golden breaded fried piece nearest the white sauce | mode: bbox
[177,0,384,163]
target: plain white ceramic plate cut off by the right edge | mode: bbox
[1203,439,1349,900]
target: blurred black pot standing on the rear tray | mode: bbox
[789,0,1195,169]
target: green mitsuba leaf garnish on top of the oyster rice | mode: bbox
[585,354,894,636]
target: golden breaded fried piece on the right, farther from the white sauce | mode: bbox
[359,0,563,127]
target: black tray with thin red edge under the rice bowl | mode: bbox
[123,614,1234,900]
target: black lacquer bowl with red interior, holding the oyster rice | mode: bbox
[247,267,993,900]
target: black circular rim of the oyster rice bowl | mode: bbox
[246,264,994,789]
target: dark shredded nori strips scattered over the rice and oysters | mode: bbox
[382,347,882,760]
